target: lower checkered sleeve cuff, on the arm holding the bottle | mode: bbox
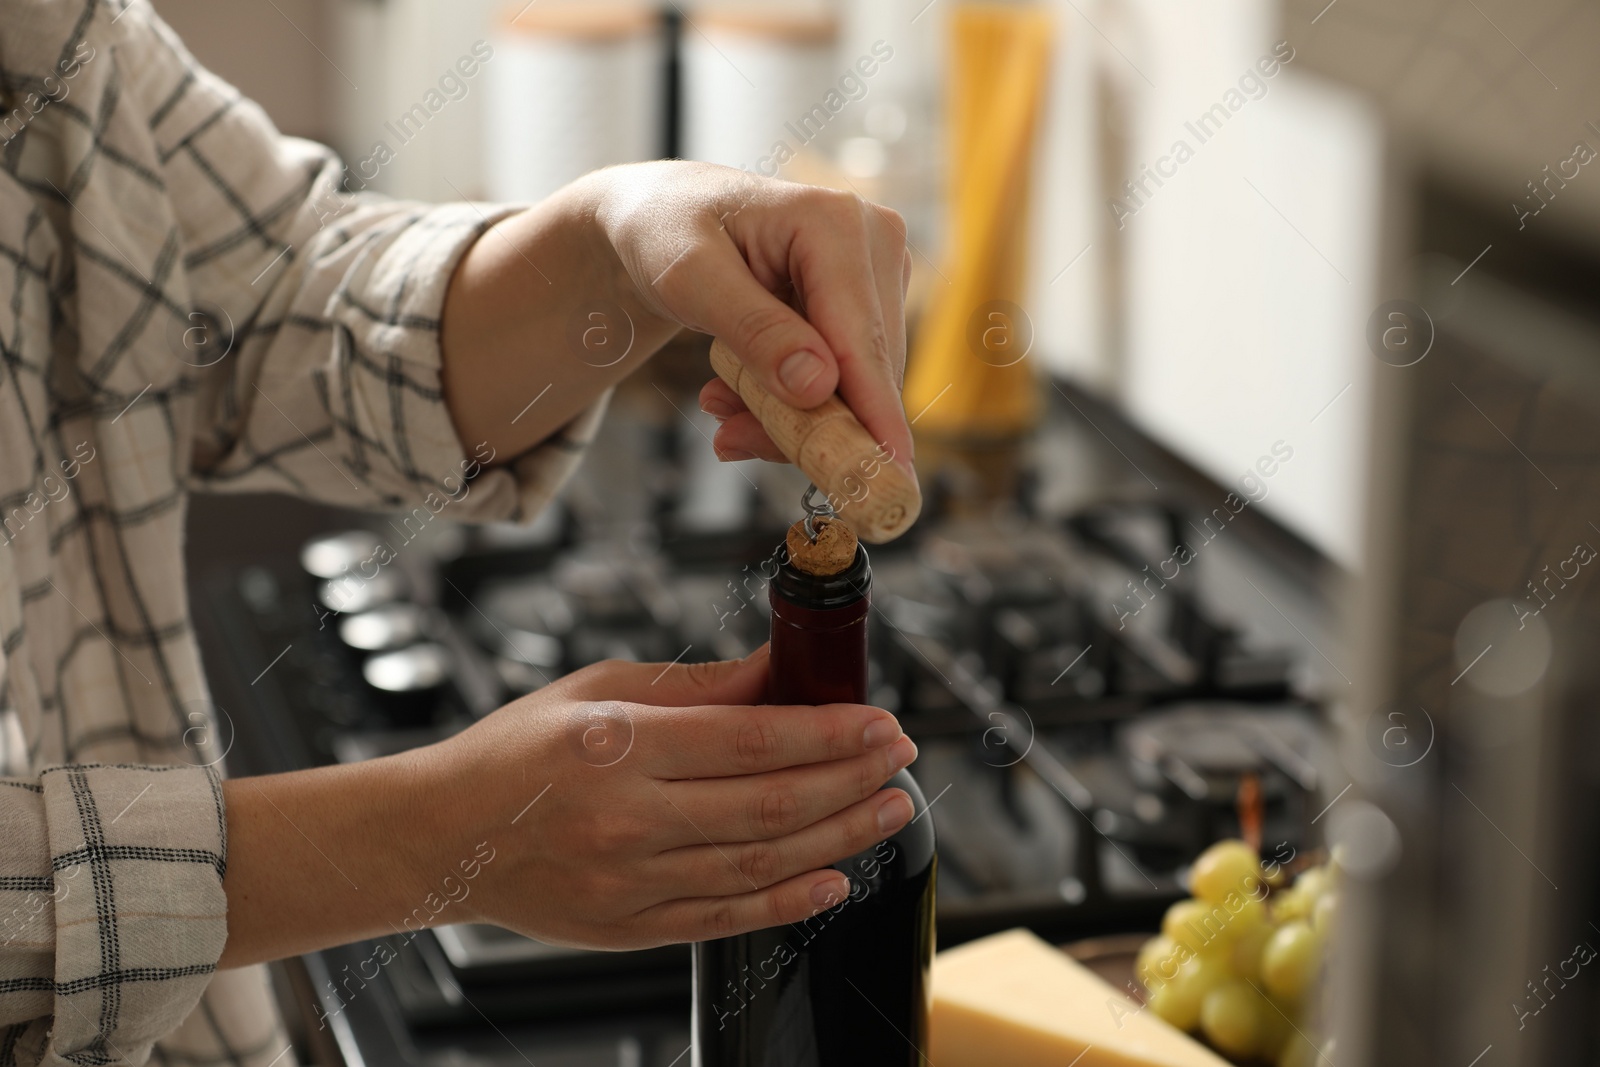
[0,765,227,1064]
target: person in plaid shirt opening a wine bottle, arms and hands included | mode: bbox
[0,0,915,1064]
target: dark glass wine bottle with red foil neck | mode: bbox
[693,545,936,1067]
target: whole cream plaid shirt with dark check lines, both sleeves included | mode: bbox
[0,0,603,1067]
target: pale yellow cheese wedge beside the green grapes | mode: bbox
[928,929,1229,1067]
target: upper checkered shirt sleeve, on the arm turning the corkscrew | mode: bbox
[134,3,605,520]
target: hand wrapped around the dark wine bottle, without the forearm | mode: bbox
[429,646,917,949]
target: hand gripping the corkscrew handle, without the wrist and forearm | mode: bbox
[594,162,912,467]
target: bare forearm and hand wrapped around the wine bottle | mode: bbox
[221,648,917,966]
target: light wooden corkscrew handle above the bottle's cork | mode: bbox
[710,339,922,544]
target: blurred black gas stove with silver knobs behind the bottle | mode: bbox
[196,467,1326,1067]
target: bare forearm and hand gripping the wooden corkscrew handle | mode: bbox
[440,160,912,470]
